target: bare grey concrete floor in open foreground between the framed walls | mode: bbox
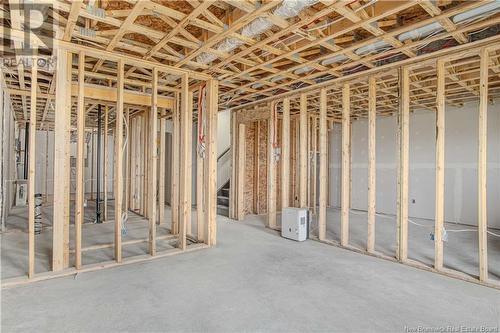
[1,210,500,332]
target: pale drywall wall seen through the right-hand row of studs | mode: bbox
[330,103,500,228]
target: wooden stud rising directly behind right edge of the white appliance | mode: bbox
[299,94,307,208]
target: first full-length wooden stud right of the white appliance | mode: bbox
[318,88,328,240]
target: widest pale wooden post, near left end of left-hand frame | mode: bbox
[52,48,71,271]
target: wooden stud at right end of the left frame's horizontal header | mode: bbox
[170,93,181,235]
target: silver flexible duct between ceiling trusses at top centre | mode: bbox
[196,0,318,64]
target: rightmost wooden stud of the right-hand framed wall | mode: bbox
[477,48,489,281]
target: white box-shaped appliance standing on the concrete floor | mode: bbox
[281,207,309,242]
